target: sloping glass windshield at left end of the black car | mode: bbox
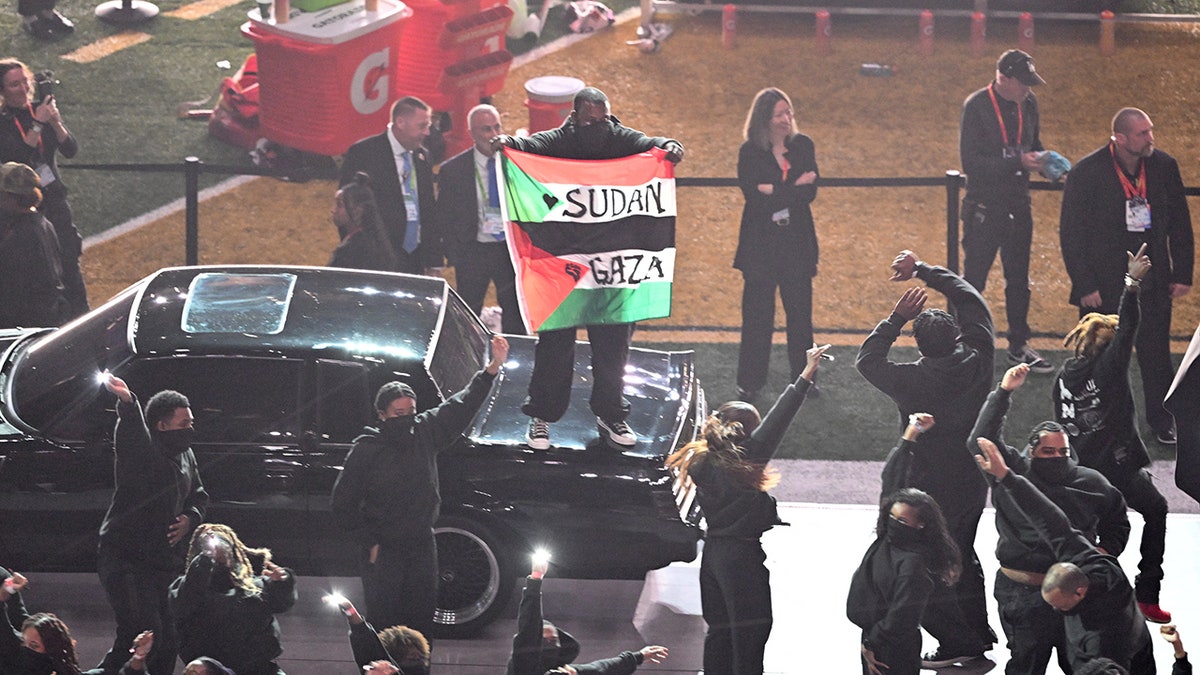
[6,287,137,441]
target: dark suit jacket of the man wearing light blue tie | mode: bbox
[338,131,442,266]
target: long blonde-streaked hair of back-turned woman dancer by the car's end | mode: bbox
[667,404,779,491]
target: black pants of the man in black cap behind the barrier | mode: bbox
[962,199,1033,350]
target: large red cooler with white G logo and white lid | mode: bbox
[241,0,413,155]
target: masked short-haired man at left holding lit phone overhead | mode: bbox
[86,372,209,675]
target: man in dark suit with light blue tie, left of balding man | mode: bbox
[338,96,442,274]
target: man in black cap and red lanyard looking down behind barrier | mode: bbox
[959,49,1054,372]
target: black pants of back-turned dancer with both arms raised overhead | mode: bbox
[917,485,996,656]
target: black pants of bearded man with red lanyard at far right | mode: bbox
[1079,277,1175,432]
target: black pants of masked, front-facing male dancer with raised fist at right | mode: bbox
[996,572,1072,675]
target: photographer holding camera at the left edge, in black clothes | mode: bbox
[0,57,88,318]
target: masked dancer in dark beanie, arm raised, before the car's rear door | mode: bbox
[332,335,509,635]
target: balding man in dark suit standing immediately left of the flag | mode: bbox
[433,104,526,335]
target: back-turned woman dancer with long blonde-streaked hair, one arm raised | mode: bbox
[667,345,829,675]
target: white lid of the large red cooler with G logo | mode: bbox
[248,0,413,44]
